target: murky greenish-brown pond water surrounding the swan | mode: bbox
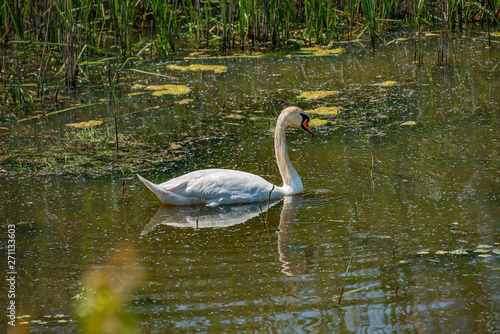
[0,39,500,333]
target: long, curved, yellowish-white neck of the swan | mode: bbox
[274,113,304,195]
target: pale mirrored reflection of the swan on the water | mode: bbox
[141,195,308,276]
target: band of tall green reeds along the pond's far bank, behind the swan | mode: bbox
[0,0,500,87]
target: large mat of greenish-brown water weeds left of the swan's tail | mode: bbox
[0,126,186,176]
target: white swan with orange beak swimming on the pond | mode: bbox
[137,107,314,206]
